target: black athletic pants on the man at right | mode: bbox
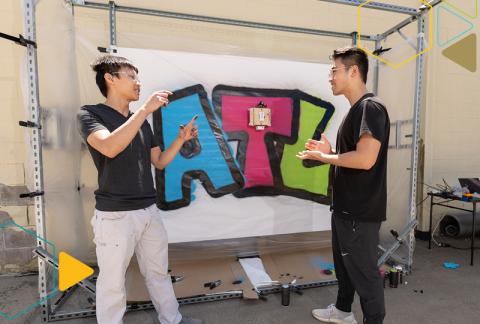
[332,215,385,324]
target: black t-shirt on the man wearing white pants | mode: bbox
[77,104,158,211]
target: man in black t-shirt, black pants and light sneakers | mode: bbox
[297,47,390,324]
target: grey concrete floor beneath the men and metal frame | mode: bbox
[0,241,480,324]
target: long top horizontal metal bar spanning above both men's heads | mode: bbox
[71,1,374,41]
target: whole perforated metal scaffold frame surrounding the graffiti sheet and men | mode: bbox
[17,0,441,322]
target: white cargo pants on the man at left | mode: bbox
[91,205,182,324]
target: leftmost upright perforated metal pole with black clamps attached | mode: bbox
[23,0,50,322]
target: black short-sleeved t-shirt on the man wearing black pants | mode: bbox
[330,93,390,222]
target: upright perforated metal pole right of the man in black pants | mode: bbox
[408,11,428,267]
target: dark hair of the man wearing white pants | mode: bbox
[90,55,138,98]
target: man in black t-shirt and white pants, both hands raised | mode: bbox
[77,55,203,324]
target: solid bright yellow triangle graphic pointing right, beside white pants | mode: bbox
[58,252,93,291]
